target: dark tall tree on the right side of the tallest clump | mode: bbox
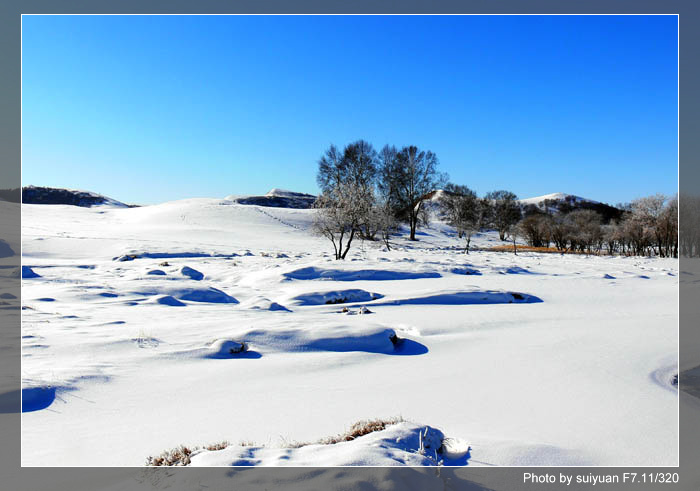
[380,145,446,240]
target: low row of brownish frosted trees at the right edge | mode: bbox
[512,194,679,257]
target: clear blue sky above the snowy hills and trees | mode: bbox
[22,15,678,204]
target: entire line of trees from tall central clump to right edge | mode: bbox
[313,140,680,259]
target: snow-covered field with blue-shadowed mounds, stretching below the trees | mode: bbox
[22,199,678,466]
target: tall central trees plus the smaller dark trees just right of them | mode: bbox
[314,140,520,259]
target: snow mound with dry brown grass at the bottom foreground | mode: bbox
[190,422,470,467]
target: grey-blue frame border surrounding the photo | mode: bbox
[0,0,700,491]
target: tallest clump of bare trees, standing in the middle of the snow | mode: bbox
[314,140,446,259]
